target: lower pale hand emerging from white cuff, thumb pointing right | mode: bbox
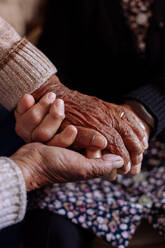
[10,143,123,191]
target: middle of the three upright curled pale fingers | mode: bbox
[19,92,56,135]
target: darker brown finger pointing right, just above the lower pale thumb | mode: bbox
[74,126,107,150]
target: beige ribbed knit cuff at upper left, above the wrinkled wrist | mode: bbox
[0,38,57,110]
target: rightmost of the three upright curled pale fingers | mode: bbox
[32,99,65,143]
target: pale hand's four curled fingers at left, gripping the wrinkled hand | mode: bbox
[15,92,77,147]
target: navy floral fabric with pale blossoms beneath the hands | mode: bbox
[31,141,165,248]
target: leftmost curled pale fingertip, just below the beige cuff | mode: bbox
[16,94,35,115]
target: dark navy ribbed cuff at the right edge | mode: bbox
[124,84,165,136]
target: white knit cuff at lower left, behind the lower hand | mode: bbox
[0,157,26,229]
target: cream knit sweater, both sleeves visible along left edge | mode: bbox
[0,13,56,229]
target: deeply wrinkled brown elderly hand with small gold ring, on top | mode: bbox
[33,75,148,177]
